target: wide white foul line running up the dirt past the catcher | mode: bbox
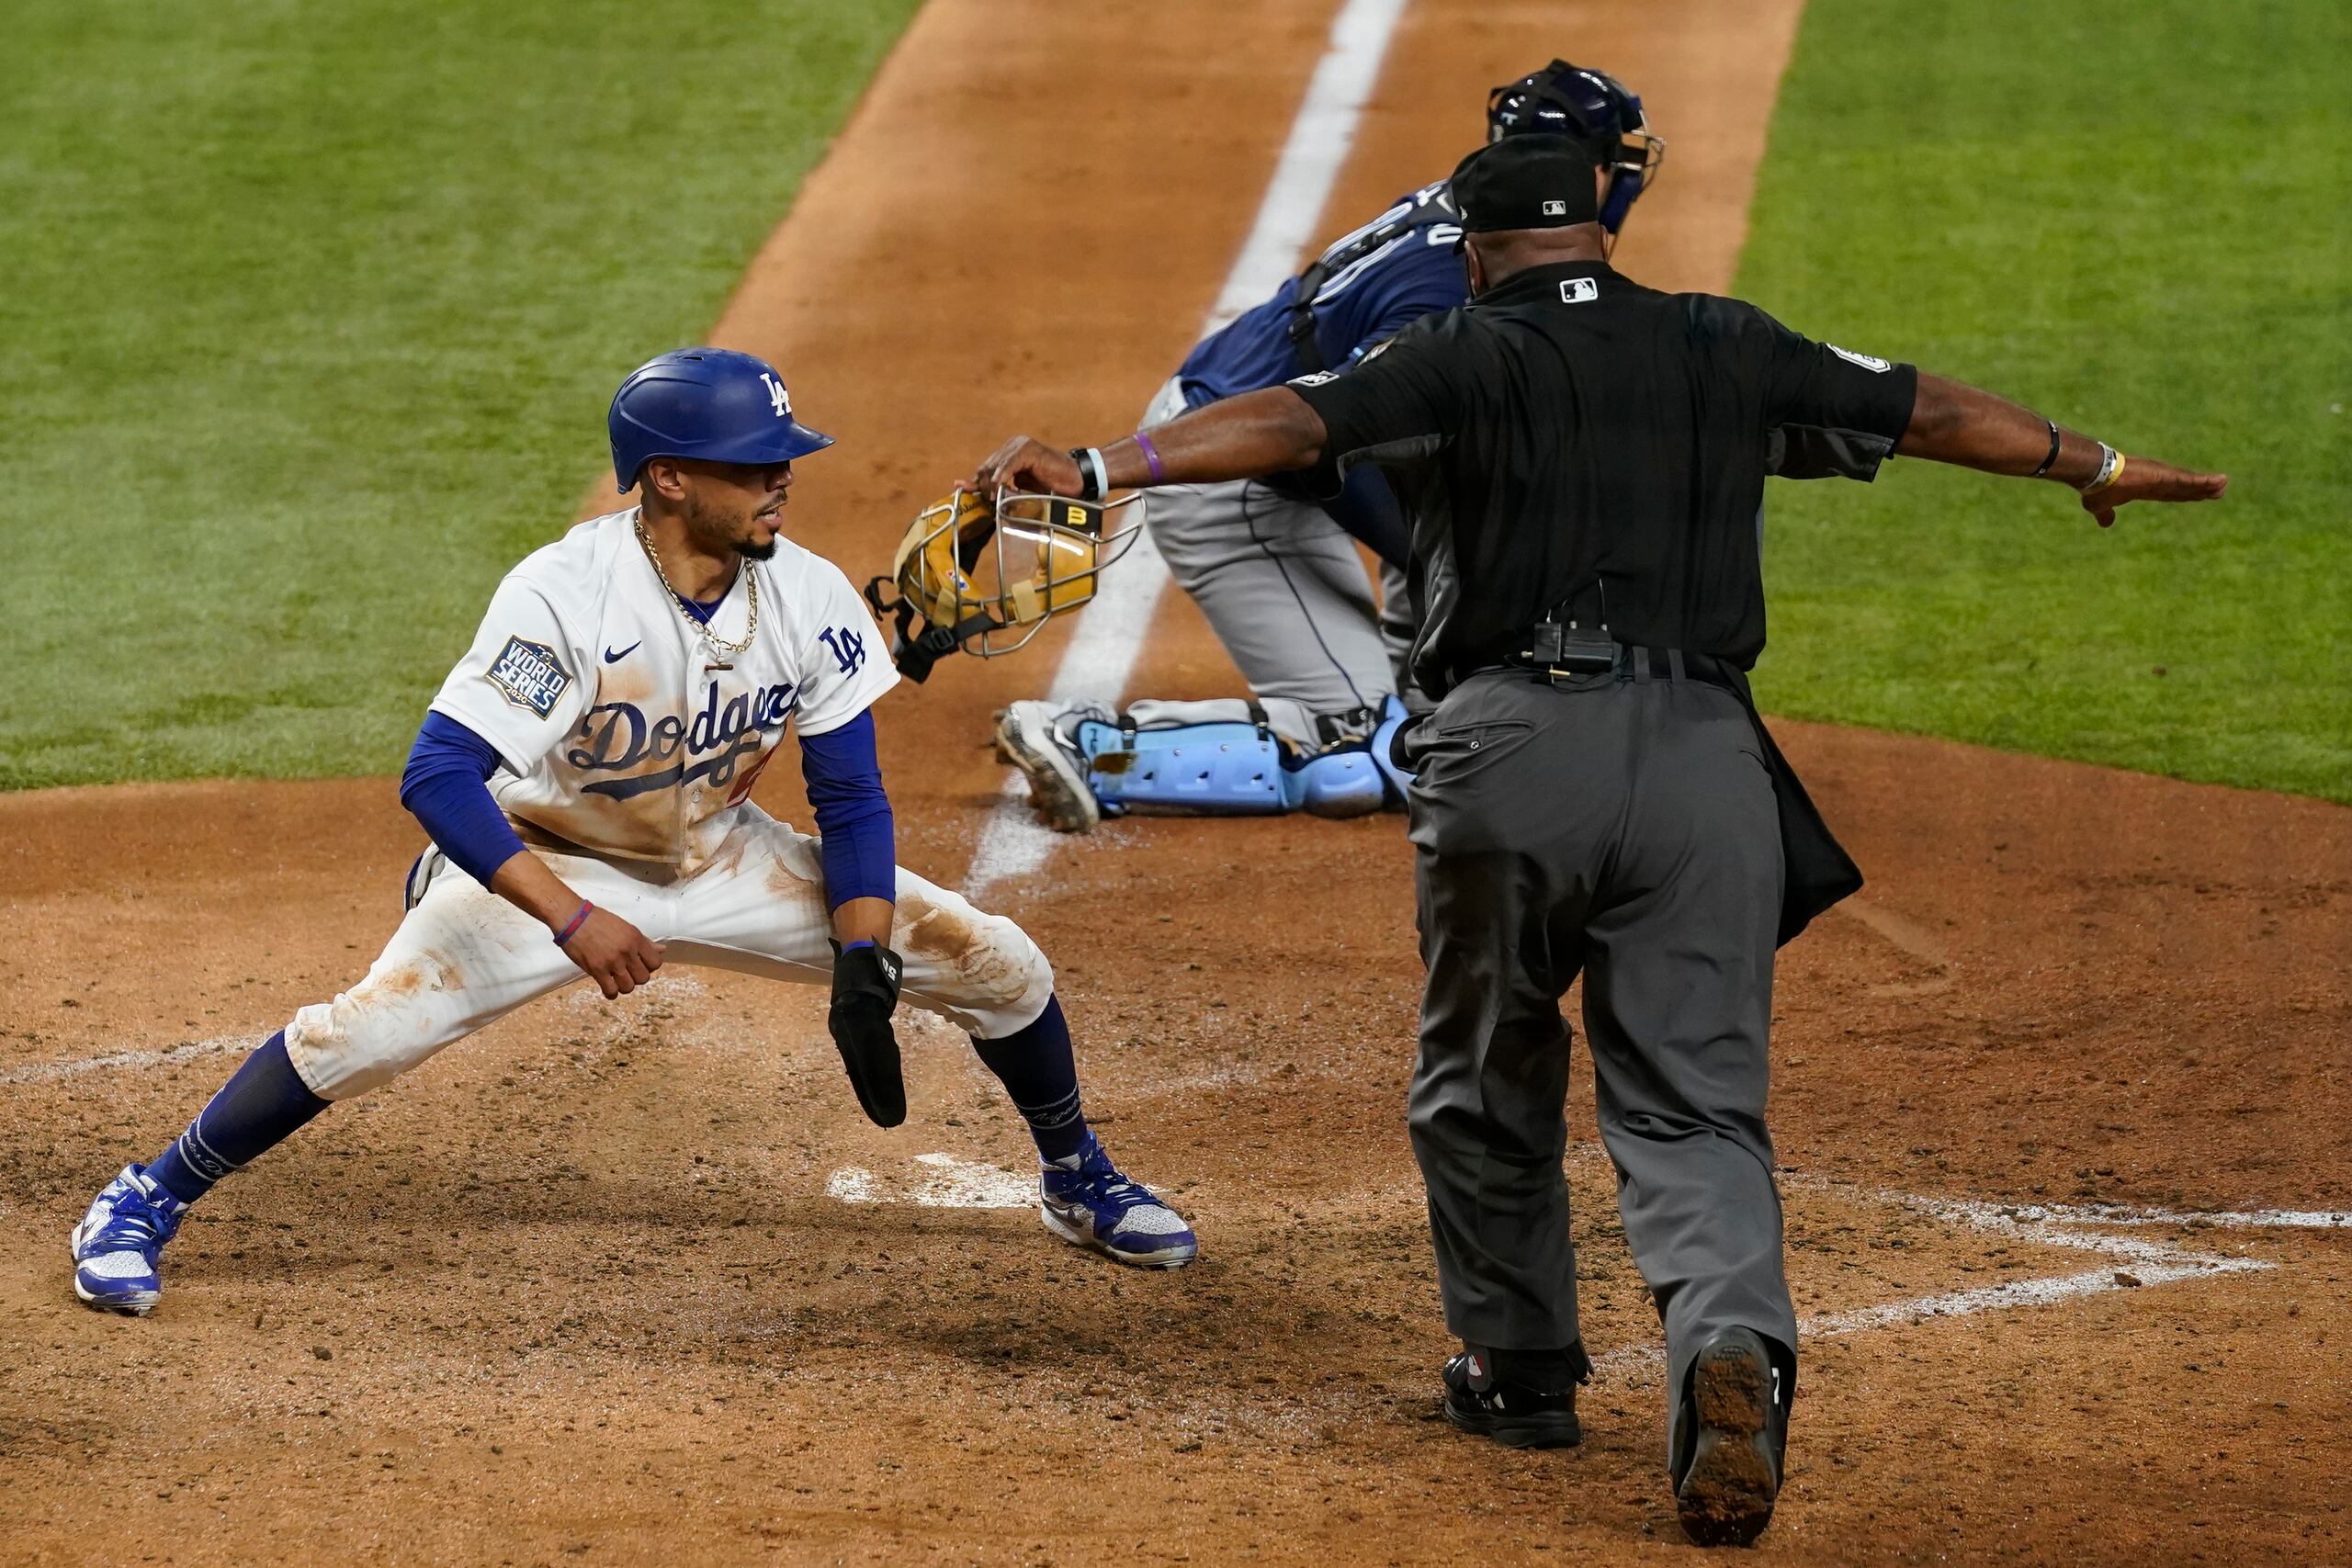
[965,0,1404,898]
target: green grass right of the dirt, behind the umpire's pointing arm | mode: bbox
[1738,0,2352,802]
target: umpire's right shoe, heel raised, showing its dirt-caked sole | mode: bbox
[1675,1328,1794,1547]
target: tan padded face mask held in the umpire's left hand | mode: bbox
[865,487,1136,682]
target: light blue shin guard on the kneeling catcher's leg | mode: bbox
[1077,698,1411,816]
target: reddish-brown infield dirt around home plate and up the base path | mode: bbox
[0,0,2352,1563]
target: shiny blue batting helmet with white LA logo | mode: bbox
[605,348,832,491]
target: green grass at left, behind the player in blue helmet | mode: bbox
[0,0,915,787]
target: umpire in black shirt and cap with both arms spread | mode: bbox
[976,136,2225,1544]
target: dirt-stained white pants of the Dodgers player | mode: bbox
[287,804,1054,1100]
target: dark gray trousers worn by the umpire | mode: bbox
[1411,651,1797,1405]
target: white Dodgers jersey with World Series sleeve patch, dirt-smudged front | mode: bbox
[433,508,899,874]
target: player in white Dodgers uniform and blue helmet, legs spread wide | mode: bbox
[73,348,1197,1314]
